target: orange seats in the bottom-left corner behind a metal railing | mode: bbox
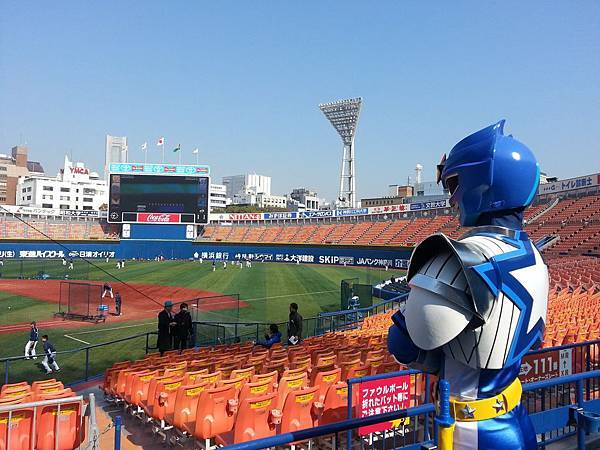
[0,379,86,450]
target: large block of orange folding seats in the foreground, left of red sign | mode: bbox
[99,312,408,445]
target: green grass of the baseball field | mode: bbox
[0,261,402,383]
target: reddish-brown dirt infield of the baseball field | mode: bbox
[0,280,247,334]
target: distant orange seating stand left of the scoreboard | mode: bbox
[0,216,119,240]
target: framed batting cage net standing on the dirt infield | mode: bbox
[56,281,107,322]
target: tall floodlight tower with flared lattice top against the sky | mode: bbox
[319,97,362,208]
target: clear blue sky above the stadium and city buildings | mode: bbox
[0,0,600,198]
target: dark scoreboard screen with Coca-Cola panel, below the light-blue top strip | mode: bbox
[108,173,210,224]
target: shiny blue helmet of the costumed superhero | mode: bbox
[438,120,540,226]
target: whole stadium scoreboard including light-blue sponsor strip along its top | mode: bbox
[108,163,210,224]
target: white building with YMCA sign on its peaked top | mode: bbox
[17,156,108,211]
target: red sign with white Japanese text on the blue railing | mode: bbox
[356,375,411,436]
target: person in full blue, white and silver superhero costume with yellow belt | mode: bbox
[388,121,548,450]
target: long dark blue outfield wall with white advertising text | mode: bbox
[0,239,412,268]
